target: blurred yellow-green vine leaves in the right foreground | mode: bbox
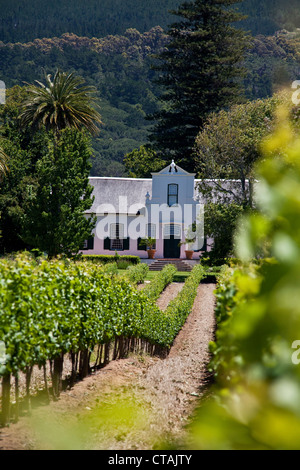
[192,108,300,450]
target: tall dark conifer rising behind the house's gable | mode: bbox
[149,0,248,171]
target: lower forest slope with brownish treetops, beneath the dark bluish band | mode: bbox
[0,27,300,176]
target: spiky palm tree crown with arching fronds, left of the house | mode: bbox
[21,71,101,137]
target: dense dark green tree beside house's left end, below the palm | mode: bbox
[21,129,95,257]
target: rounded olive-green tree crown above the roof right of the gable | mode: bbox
[195,94,278,190]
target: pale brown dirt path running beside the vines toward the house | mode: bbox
[0,284,215,450]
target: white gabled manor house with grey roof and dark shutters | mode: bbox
[83,161,206,259]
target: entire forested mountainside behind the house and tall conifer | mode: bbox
[0,0,300,176]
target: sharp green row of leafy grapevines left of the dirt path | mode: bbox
[0,255,204,424]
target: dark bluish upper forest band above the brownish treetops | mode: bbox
[0,0,300,42]
